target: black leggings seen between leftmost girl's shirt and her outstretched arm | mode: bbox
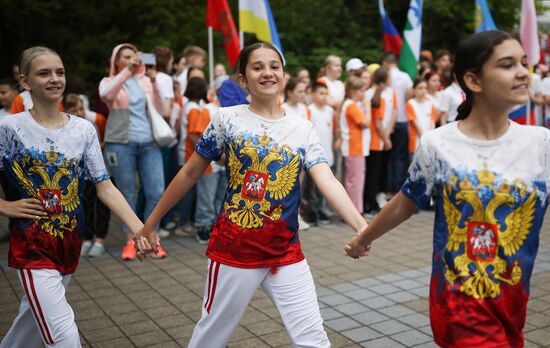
[84,181,111,240]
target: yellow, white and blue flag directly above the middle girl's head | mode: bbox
[239,0,283,55]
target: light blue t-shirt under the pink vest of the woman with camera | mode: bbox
[128,76,153,143]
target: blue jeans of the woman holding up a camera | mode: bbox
[105,142,164,232]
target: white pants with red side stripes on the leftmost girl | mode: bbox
[0,269,81,348]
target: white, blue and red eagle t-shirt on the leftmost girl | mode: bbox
[0,111,109,274]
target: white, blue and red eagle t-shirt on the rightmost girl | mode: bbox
[401,122,550,347]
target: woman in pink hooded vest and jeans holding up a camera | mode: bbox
[99,43,166,260]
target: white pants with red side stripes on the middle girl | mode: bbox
[189,260,330,348]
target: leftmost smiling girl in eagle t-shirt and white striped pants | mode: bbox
[0,47,143,348]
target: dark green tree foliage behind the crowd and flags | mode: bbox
[0,0,532,96]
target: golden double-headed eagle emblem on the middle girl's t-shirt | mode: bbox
[224,135,300,228]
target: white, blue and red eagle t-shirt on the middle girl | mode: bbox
[195,105,327,268]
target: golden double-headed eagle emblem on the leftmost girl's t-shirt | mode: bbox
[12,146,80,239]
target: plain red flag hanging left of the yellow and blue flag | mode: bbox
[206,0,241,68]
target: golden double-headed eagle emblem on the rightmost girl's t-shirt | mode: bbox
[443,165,537,299]
